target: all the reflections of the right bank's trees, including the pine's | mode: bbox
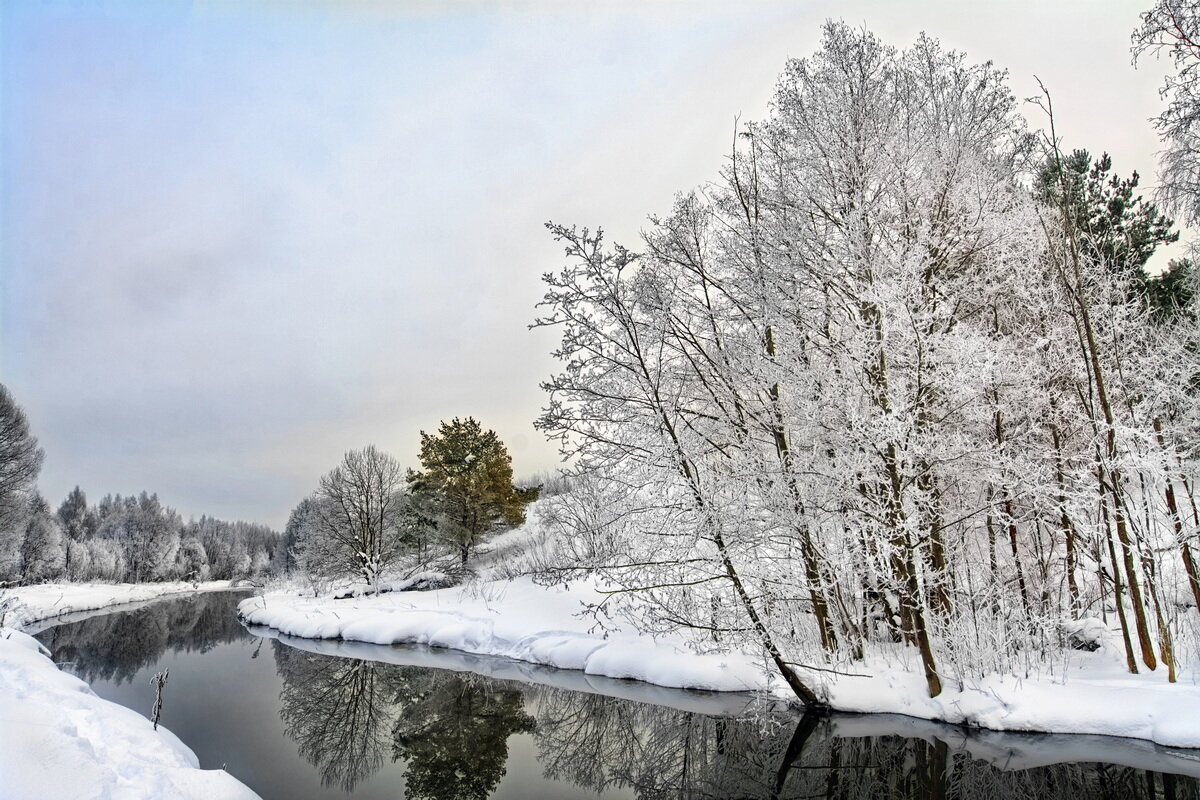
[272,642,1200,800]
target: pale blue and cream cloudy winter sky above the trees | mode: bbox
[0,0,1180,527]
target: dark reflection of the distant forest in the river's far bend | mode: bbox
[35,591,250,684]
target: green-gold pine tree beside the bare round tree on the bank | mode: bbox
[408,417,534,564]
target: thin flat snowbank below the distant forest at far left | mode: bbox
[0,581,242,631]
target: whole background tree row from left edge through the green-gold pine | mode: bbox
[0,385,538,588]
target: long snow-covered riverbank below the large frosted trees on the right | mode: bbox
[239,578,1200,747]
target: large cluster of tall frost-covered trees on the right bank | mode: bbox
[535,18,1200,704]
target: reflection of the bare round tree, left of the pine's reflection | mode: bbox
[274,642,395,792]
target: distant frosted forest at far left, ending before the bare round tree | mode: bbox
[0,385,280,583]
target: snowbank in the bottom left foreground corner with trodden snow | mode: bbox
[0,628,258,800]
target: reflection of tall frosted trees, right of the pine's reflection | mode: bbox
[534,690,1200,800]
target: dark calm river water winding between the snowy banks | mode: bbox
[37,593,1200,800]
